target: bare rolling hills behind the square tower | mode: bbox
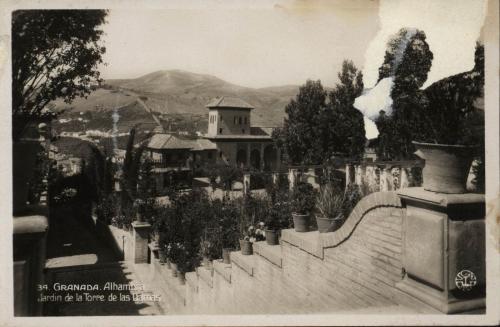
[56,70,298,126]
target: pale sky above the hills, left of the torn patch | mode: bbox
[97,0,379,87]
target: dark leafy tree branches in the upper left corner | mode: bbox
[12,10,107,139]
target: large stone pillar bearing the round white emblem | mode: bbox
[396,187,486,313]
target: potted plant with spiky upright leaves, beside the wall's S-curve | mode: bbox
[316,183,345,233]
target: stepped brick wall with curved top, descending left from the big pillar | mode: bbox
[147,192,433,314]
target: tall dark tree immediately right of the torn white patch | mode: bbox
[375,28,433,160]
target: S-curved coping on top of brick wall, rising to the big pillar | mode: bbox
[281,191,402,259]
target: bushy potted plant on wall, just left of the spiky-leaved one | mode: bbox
[292,182,315,233]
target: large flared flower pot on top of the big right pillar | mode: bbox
[413,142,475,193]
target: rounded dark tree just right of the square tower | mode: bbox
[273,80,327,165]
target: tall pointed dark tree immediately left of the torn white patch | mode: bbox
[319,60,366,159]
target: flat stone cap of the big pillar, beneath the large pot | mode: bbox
[398,187,485,207]
